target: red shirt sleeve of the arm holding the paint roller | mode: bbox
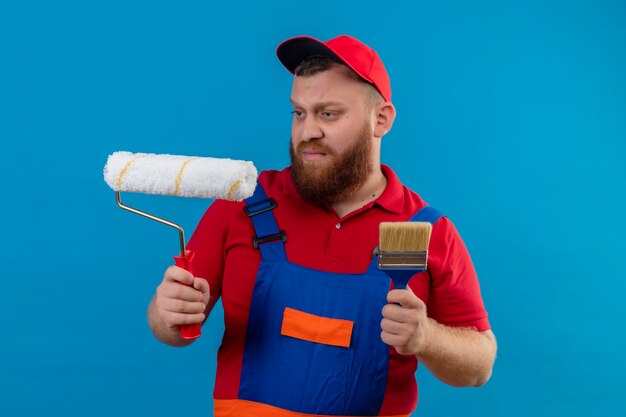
[187,200,233,297]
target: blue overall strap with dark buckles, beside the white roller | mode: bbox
[243,183,287,261]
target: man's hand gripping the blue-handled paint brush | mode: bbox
[380,286,429,355]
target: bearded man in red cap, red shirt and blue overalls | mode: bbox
[149,36,496,417]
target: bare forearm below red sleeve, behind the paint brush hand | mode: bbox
[416,319,497,386]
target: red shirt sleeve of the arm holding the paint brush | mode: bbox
[416,217,490,331]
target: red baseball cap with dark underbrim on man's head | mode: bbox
[276,35,391,101]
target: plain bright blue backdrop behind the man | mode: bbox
[0,0,626,416]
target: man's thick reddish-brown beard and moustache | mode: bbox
[289,124,373,205]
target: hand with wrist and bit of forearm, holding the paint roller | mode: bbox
[148,266,210,346]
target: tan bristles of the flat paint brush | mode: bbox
[379,222,432,251]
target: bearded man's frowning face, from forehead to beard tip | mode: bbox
[290,66,374,204]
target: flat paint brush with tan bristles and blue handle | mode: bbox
[376,222,432,289]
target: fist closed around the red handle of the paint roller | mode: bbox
[154,266,210,329]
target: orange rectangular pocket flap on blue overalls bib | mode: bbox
[280,307,354,348]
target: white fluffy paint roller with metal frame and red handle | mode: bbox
[104,152,257,339]
